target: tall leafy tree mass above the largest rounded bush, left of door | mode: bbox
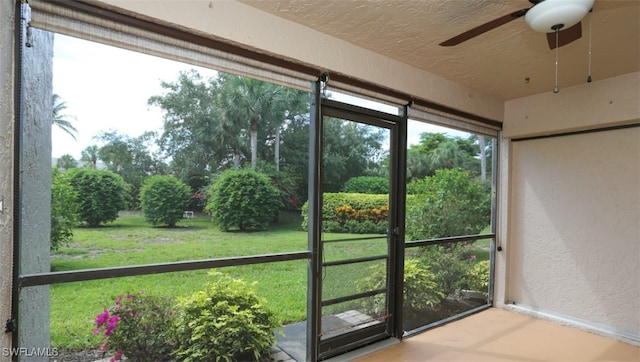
[149,71,308,186]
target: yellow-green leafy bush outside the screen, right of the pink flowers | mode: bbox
[175,271,280,361]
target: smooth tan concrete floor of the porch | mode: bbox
[352,308,640,362]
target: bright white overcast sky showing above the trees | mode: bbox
[52,34,464,159]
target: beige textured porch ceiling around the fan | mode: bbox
[240,0,640,100]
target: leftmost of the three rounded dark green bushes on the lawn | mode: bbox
[68,169,129,227]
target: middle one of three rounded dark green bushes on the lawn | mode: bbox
[140,175,191,227]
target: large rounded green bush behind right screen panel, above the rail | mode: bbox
[406,169,491,240]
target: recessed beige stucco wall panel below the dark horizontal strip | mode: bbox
[507,127,640,342]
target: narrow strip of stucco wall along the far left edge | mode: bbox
[0,0,14,361]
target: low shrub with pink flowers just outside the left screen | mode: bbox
[93,292,176,362]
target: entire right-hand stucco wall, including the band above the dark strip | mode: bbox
[496,73,640,343]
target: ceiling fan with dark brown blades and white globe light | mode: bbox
[440,0,595,49]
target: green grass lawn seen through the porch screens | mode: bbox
[50,213,488,350]
